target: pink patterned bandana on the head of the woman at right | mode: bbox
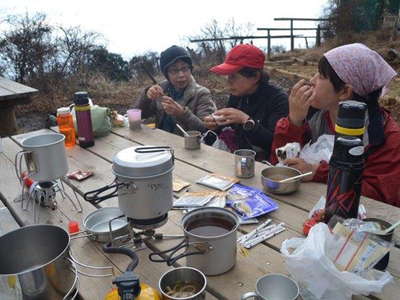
[324,43,397,97]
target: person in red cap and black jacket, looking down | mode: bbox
[204,44,288,159]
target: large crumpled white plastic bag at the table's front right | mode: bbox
[281,223,393,300]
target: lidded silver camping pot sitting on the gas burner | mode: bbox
[84,146,174,228]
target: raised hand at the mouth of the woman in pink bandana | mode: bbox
[289,79,314,126]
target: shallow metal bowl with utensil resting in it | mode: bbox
[261,167,302,194]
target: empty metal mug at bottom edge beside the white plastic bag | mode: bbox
[241,273,299,300]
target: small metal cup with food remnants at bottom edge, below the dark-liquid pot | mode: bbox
[158,267,207,300]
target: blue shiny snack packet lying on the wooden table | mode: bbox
[226,184,278,220]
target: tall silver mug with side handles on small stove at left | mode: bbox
[15,133,68,182]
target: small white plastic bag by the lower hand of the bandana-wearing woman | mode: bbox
[299,134,335,164]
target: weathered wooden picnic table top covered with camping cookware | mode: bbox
[0,126,400,300]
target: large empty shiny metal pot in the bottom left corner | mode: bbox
[0,225,77,300]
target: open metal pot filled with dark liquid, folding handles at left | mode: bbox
[149,207,239,275]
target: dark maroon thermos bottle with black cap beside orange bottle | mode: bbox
[74,92,94,148]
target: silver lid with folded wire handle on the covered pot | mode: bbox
[113,146,174,177]
